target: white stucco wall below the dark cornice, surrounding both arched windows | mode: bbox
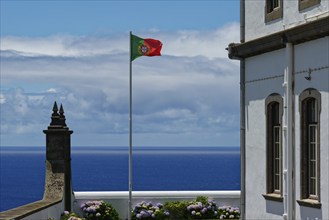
[245,37,329,219]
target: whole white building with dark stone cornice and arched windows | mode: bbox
[228,0,329,219]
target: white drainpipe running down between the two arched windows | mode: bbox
[283,36,295,220]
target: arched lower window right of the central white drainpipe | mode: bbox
[299,89,321,208]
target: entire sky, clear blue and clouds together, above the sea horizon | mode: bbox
[0,0,239,146]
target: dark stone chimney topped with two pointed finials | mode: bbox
[43,102,73,211]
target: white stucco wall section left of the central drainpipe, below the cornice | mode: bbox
[246,47,285,219]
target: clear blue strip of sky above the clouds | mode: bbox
[1,0,239,36]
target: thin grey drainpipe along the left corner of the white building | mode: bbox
[240,0,246,219]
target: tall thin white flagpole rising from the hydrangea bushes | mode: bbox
[128,31,133,220]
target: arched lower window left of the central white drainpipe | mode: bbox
[264,94,283,201]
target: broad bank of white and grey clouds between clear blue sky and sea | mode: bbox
[0,24,239,145]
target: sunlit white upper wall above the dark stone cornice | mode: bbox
[245,0,329,41]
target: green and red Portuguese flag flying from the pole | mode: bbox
[130,34,162,61]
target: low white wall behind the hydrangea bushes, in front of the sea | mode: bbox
[73,191,240,219]
